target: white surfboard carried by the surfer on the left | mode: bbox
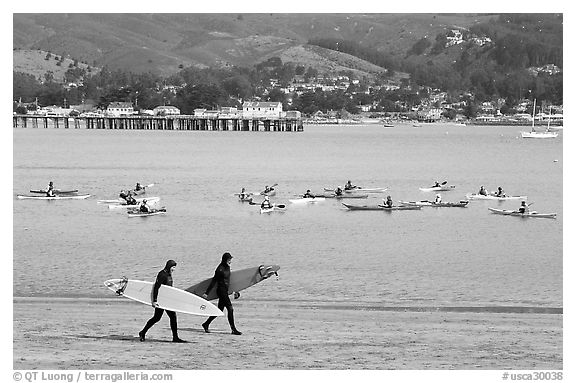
[104,278,224,316]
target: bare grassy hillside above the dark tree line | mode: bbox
[13,14,494,75]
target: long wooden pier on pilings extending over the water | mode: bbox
[13,114,304,132]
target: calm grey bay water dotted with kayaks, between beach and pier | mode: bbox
[13,125,563,307]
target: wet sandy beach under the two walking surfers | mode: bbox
[13,297,563,370]
